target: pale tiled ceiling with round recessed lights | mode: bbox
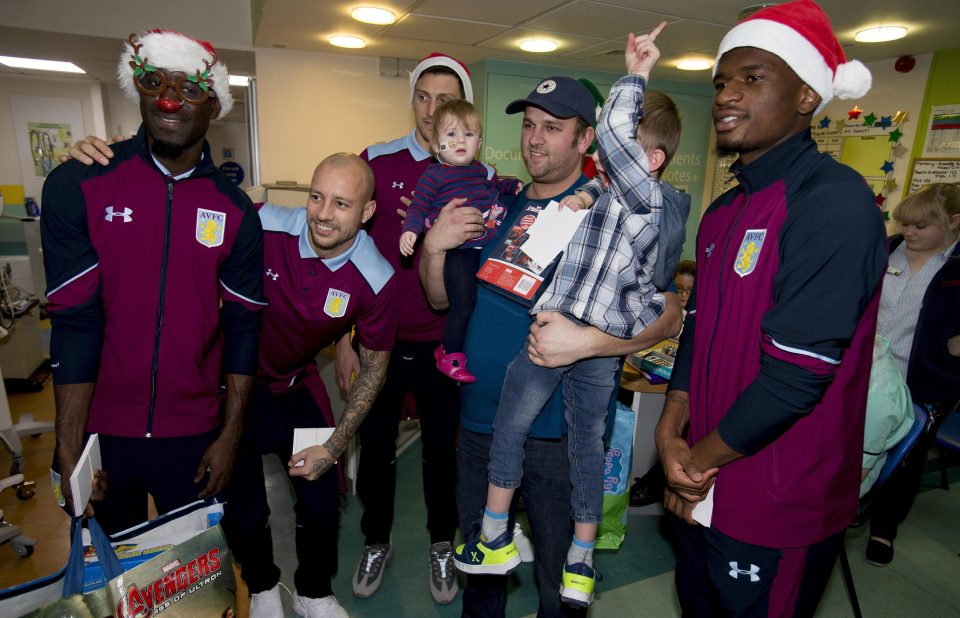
[0,0,960,81]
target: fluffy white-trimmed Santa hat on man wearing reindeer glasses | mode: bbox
[117,30,233,118]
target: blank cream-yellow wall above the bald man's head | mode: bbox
[256,49,413,184]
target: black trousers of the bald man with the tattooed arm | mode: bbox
[223,377,340,598]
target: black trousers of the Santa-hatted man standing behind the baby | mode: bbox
[357,336,464,545]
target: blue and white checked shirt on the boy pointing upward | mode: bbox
[531,75,664,339]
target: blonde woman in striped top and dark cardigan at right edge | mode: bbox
[867,183,960,566]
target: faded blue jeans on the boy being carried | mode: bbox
[487,348,620,524]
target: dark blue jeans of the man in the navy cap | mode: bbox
[457,427,587,618]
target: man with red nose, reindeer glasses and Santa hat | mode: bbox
[41,30,265,532]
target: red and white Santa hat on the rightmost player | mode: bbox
[713,0,872,114]
